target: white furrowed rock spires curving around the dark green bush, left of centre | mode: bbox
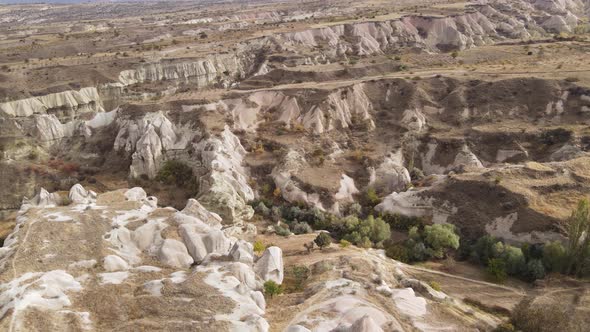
[114,112,254,223]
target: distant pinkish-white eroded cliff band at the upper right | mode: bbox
[270,1,584,57]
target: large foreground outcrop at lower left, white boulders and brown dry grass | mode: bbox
[0,185,283,331]
